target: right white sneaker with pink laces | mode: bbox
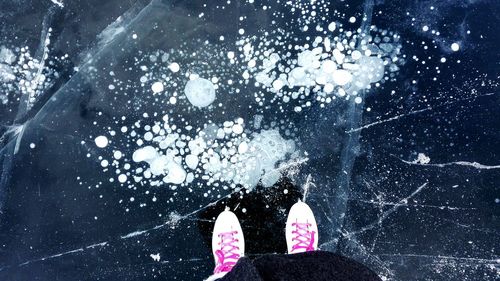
[285,201,318,254]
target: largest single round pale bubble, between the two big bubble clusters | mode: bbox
[184,78,215,107]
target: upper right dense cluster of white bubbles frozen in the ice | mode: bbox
[238,23,401,108]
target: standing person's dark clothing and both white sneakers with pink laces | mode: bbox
[208,202,381,281]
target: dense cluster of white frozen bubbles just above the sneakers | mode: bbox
[95,115,295,189]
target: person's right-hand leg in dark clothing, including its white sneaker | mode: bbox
[252,202,381,281]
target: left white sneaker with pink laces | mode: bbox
[212,209,245,279]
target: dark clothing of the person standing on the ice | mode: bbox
[218,251,382,281]
